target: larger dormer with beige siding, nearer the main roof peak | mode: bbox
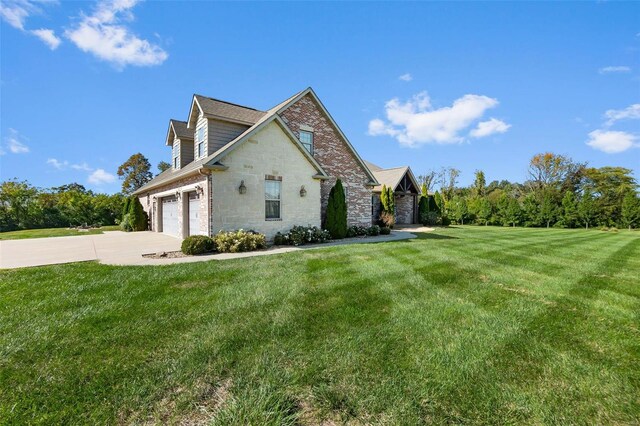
[187,95,265,160]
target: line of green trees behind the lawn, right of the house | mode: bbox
[418,153,640,229]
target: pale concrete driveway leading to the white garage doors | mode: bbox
[0,231,181,268]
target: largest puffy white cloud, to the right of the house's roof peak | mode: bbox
[369,92,509,146]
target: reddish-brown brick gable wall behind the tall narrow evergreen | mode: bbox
[281,94,372,226]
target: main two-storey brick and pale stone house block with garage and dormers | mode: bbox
[134,88,390,238]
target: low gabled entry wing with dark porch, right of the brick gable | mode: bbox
[365,161,420,224]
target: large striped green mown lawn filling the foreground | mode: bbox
[0,227,640,425]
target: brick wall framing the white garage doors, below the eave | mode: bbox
[138,174,211,238]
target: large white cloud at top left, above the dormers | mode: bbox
[64,0,169,69]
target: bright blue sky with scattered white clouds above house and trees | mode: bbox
[0,0,640,193]
